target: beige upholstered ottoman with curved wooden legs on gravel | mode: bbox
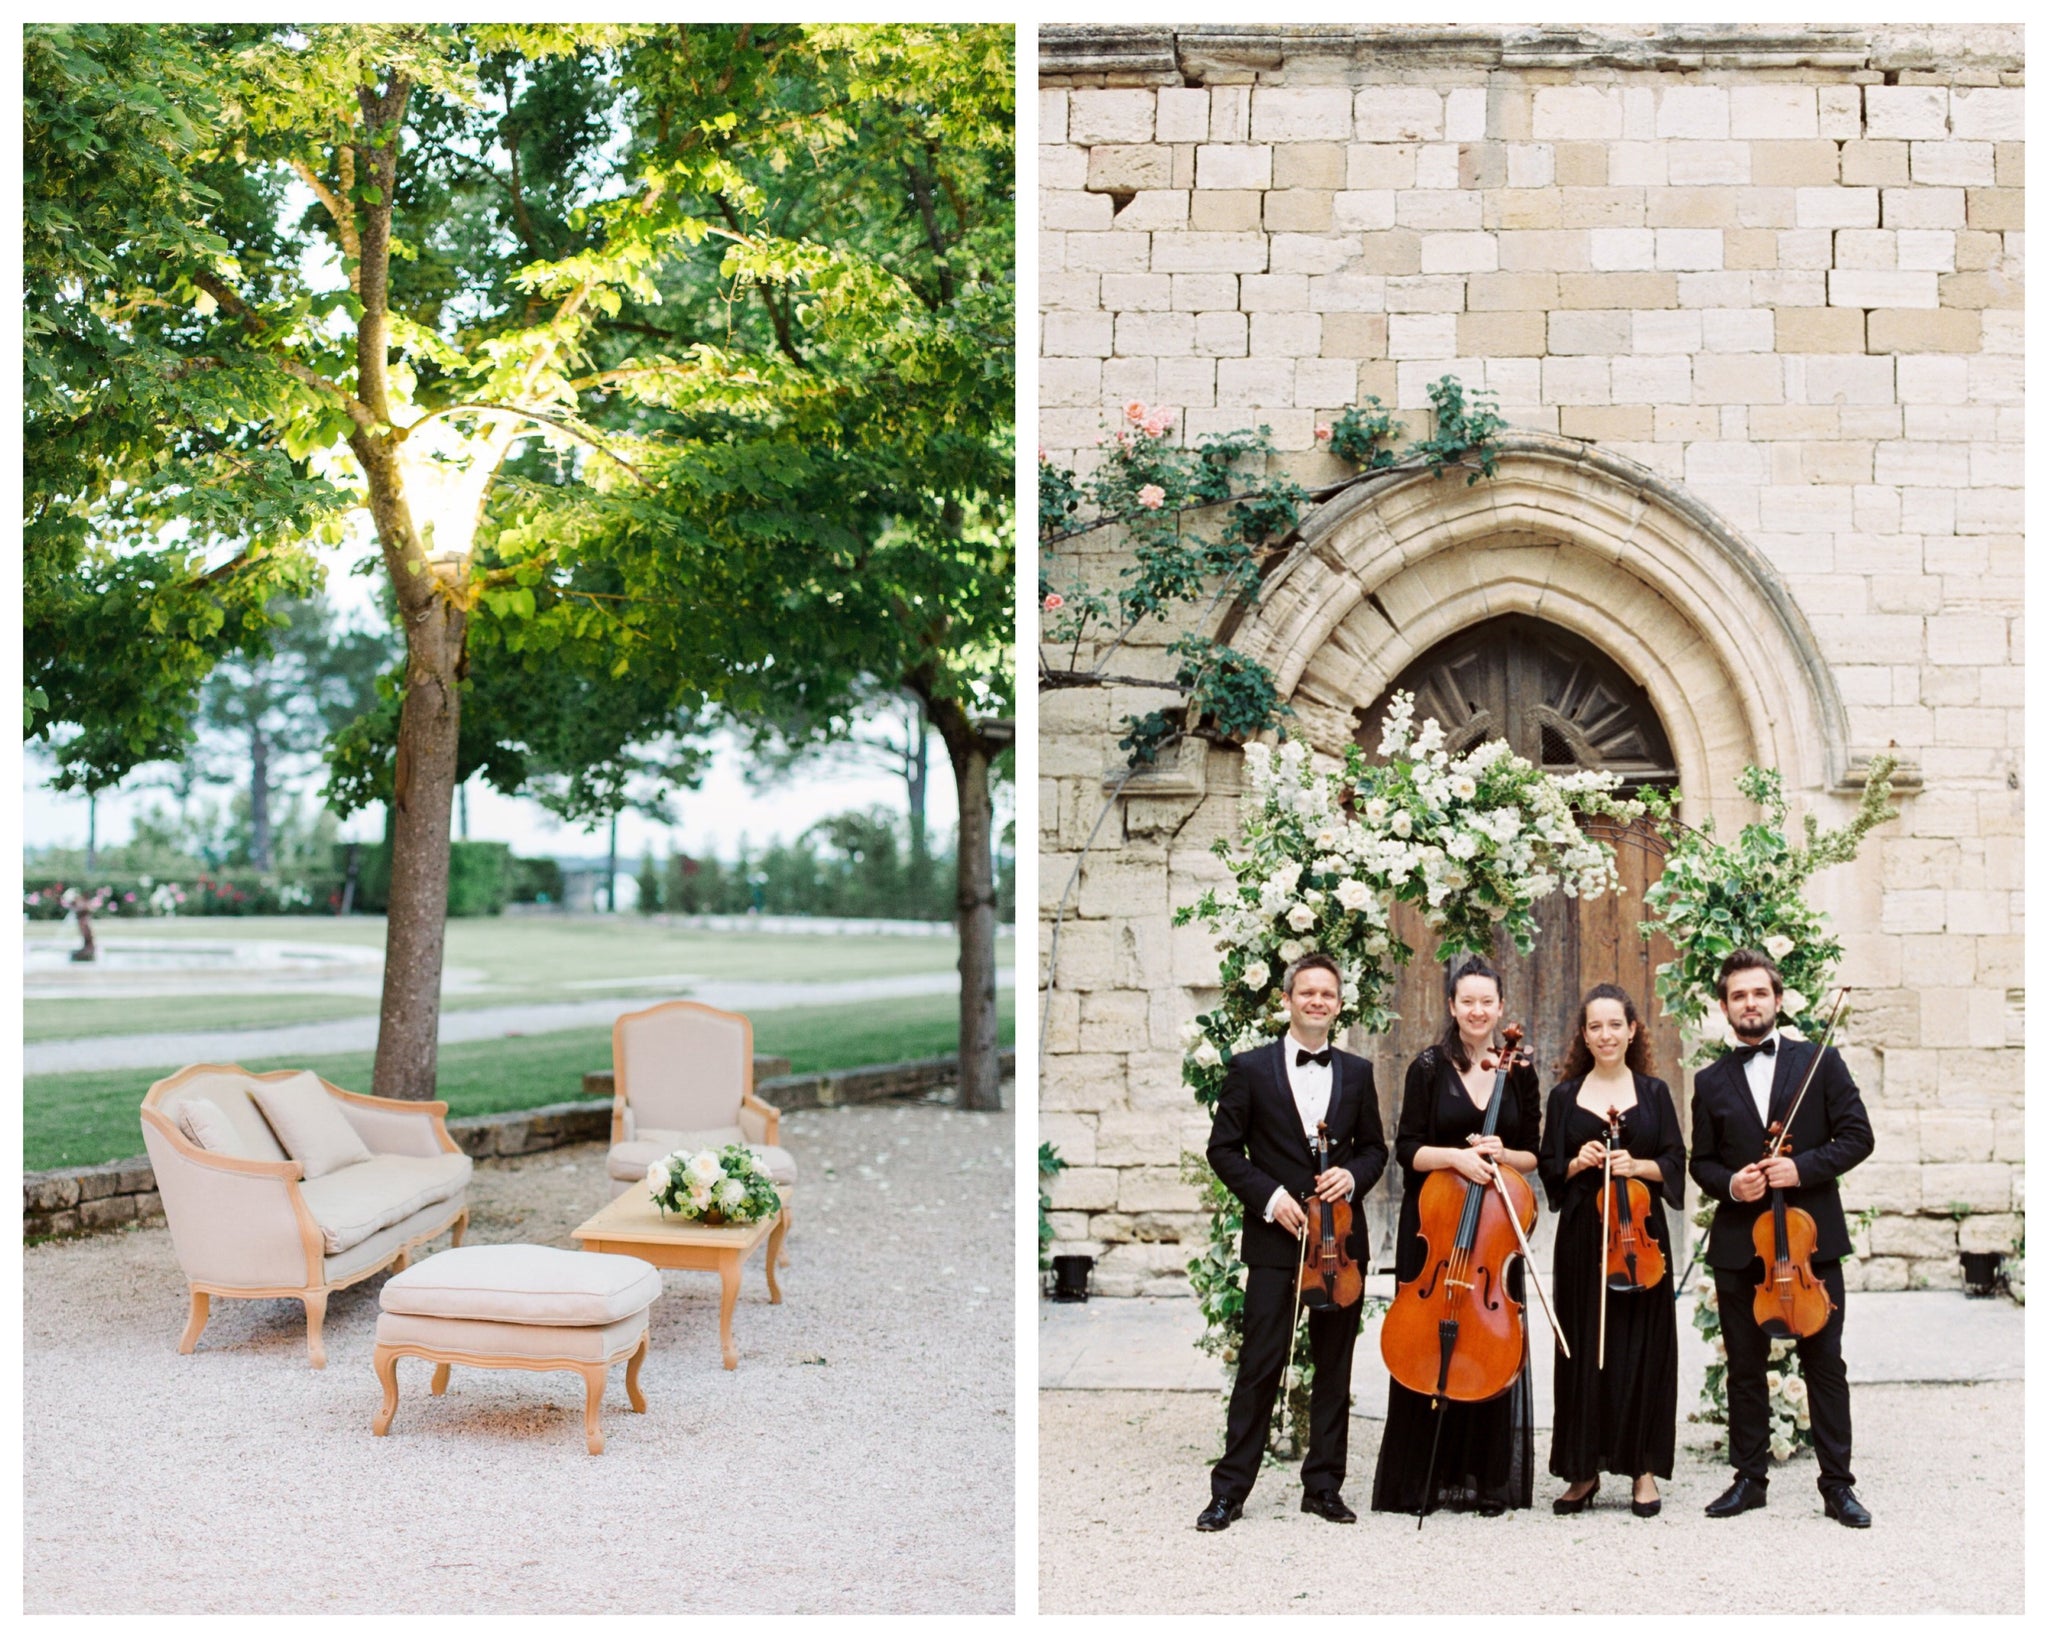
[373,1245,662,1456]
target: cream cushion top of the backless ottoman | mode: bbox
[377,1245,662,1337]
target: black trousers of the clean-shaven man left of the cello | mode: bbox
[1208,1267,1366,1501]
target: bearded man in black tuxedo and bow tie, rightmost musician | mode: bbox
[1692,950,1876,1529]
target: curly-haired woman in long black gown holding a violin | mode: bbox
[1540,985,1686,1519]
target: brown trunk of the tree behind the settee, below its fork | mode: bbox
[371,596,467,1097]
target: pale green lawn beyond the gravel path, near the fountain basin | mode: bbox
[23,915,1016,1040]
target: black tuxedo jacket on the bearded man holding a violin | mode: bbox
[1692,1036,1876,1271]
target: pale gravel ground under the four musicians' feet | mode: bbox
[1038,1382,2025,1615]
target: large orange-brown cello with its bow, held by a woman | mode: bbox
[1380,1024,1571,1529]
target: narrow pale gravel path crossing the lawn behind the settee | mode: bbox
[23,966,1016,1075]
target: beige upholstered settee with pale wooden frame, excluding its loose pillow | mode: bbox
[141,1063,469,1368]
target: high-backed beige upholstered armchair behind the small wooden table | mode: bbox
[606,1001,797,1236]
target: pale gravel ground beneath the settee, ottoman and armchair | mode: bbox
[23,1106,1016,1613]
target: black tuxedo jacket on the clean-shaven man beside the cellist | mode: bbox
[1208,1036,1386,1269]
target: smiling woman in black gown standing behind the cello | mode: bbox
[1372,956,1542,1517]
